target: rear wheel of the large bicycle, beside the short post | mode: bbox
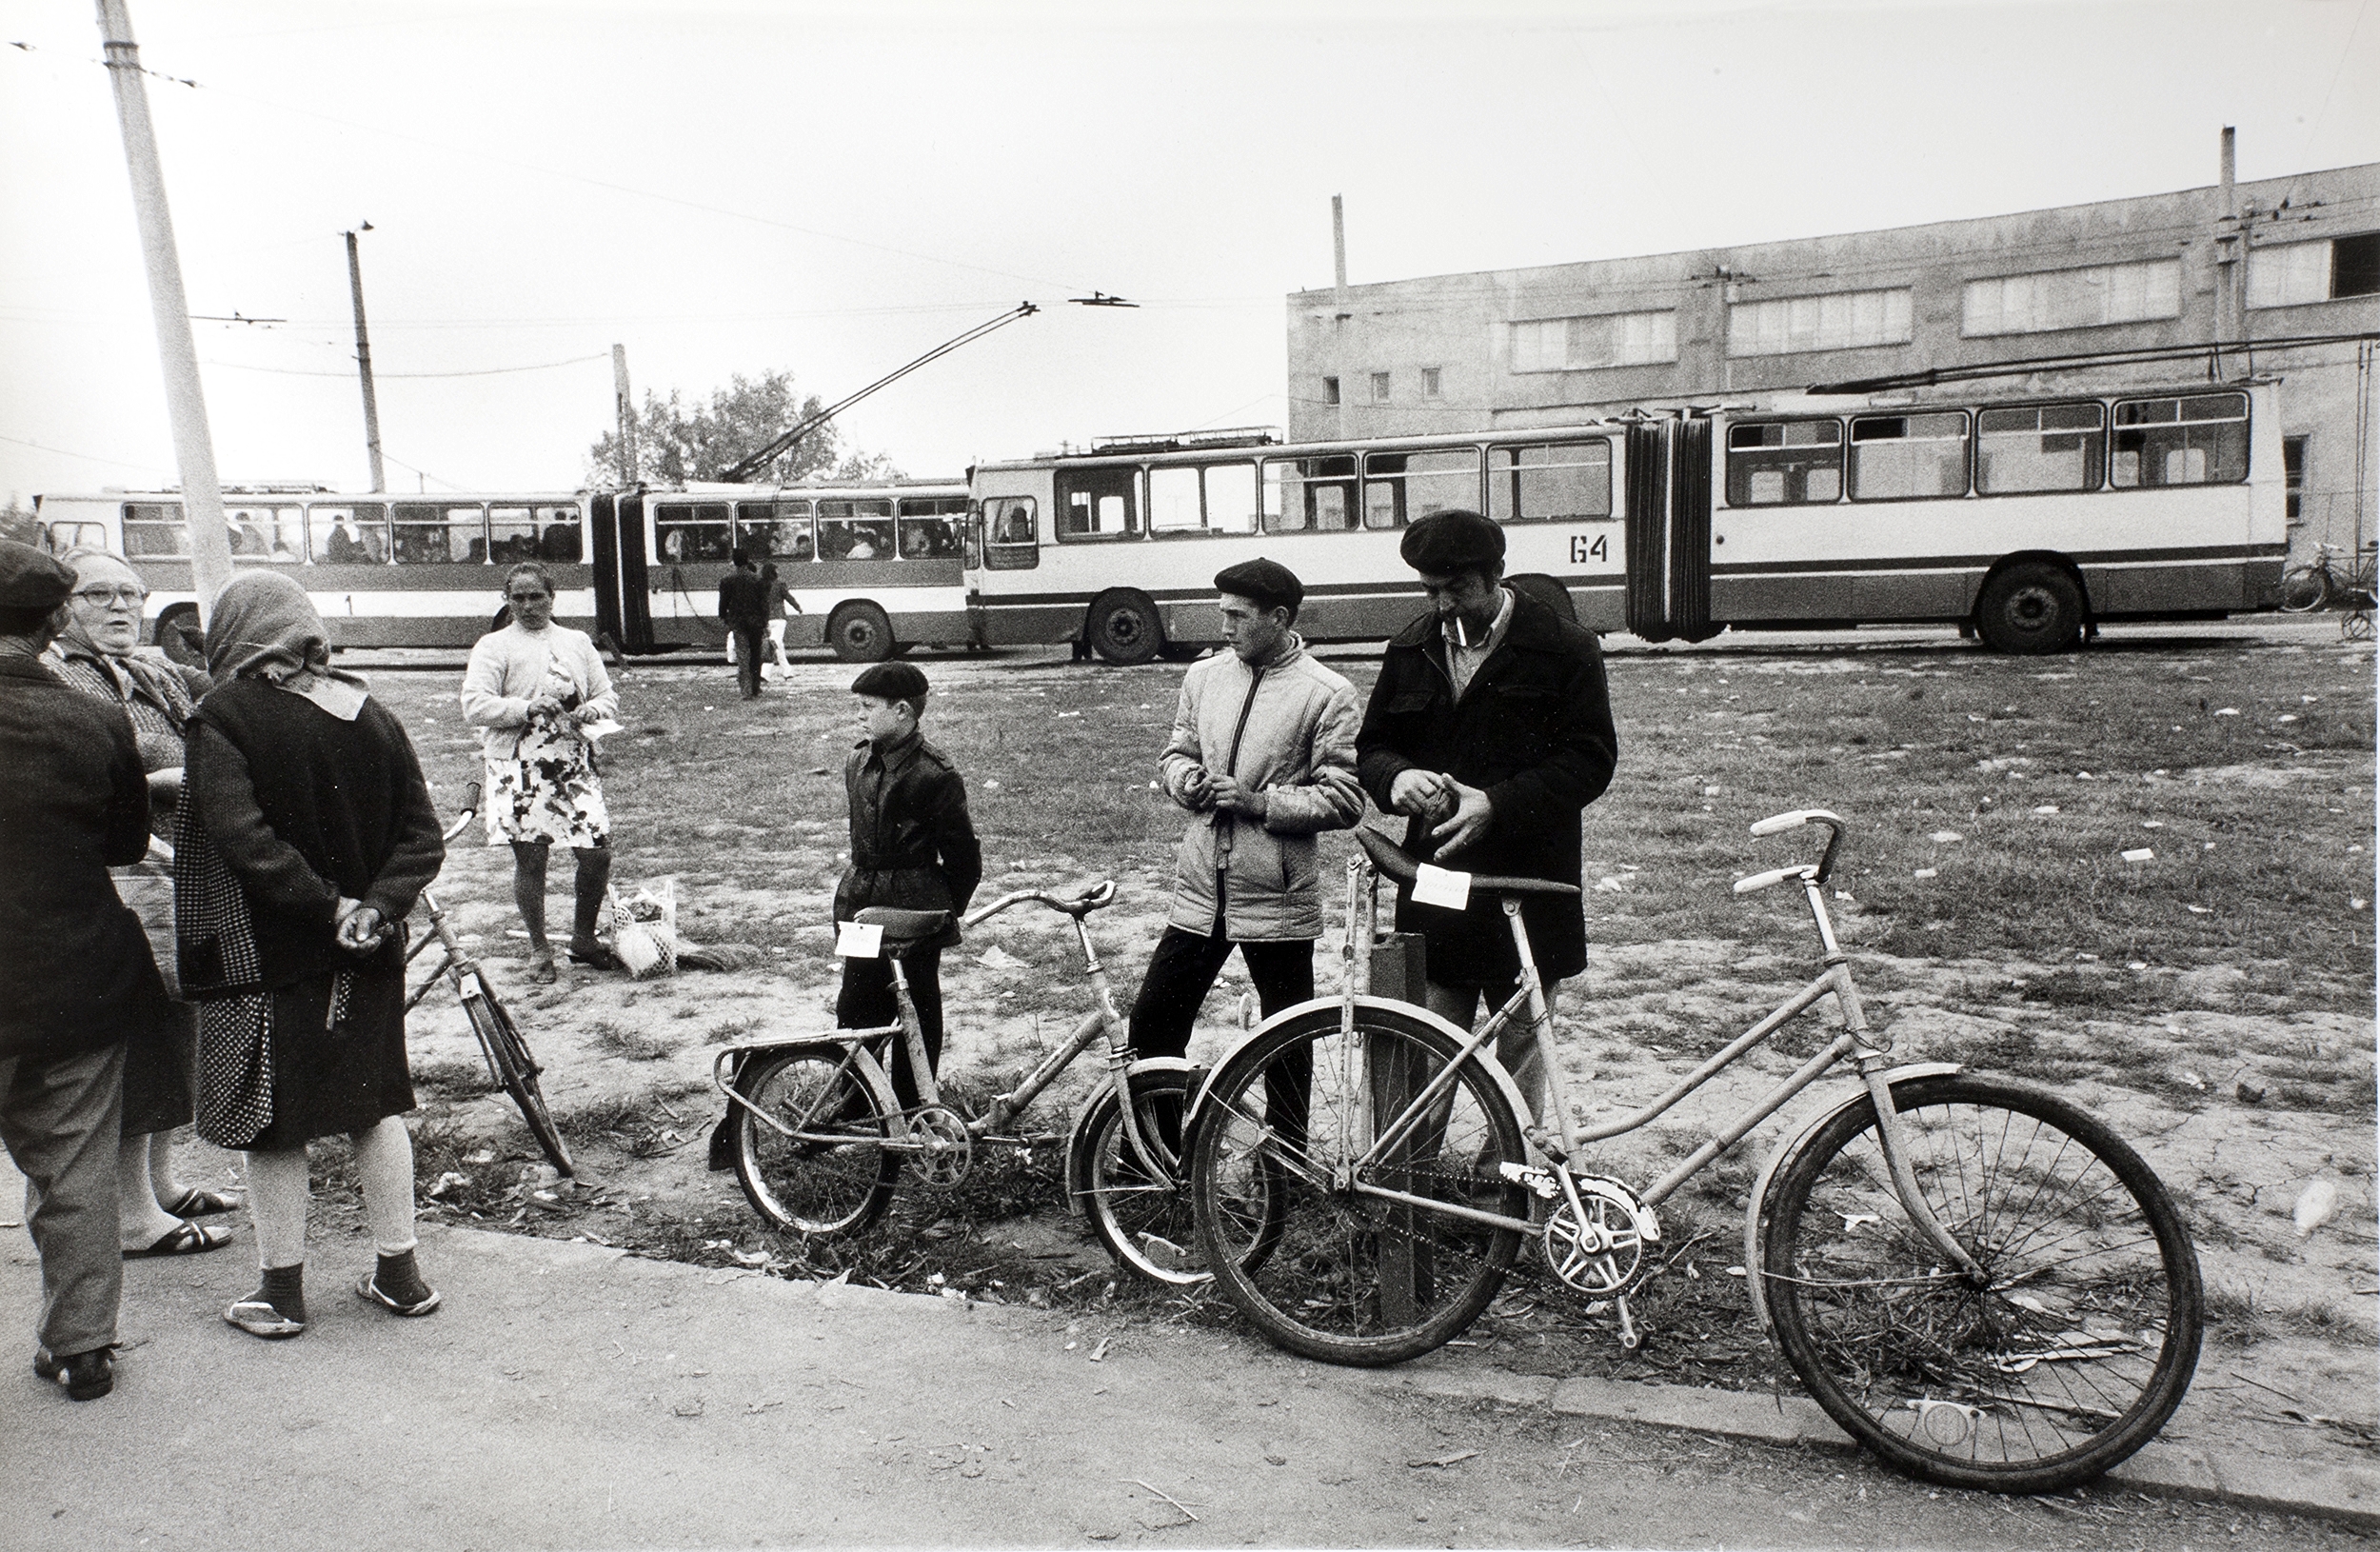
[1190,1007,1528,1364]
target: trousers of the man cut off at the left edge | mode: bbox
[0,1041,124,1355]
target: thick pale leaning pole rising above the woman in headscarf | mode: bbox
[98,0,231,624]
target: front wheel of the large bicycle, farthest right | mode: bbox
[1759,1076,2202,1493]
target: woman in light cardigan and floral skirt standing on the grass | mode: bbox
[462,562,619,984]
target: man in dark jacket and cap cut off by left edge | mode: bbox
[0,541,174,1403]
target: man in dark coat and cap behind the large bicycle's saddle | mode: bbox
[1357,512,1618,1112]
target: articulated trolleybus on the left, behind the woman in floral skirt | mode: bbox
[36,481,974,662]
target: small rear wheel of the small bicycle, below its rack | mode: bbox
[736,1045,900,1233]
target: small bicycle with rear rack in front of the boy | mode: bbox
[712,881,1207,1285]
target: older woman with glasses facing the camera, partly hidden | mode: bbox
[46,550,241,1257]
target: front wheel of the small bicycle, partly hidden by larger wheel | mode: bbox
[1083,1071,1209,1288]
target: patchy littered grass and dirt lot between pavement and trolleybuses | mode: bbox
[190,643,2380,1495]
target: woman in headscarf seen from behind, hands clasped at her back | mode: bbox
[174,571,446,1338]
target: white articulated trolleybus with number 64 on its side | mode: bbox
[966,381,2288,665]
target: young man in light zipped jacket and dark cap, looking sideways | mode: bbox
[1133,560,1364,1081]
